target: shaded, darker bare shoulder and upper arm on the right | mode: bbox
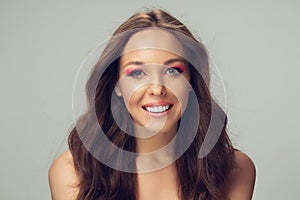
[225,151,256,200]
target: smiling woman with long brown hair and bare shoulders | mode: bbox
[49,9,255,200]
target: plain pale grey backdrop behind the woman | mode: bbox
[0,0,300,200]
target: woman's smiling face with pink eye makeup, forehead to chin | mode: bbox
[115,29,190,134]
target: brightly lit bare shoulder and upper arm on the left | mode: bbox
[48,151,79,200]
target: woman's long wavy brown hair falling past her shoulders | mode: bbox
[68,9,234,200]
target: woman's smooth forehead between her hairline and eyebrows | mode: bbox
[122,28,184,57]
